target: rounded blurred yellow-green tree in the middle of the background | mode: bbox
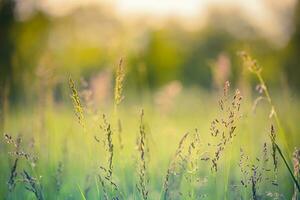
[141,24,188,88]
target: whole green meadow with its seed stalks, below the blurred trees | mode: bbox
[0,53,300,200]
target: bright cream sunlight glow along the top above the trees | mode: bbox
[18,0,296,46]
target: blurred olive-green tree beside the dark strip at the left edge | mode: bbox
[11,11,51,103]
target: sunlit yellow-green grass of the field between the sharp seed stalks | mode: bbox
[0,87,300,199]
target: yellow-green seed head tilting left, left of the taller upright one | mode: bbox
[69,76,86,130]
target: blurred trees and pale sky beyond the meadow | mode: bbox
[0,0,300,122]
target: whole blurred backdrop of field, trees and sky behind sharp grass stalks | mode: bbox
[0,0,300,199]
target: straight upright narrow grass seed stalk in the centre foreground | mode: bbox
[137,110,149,200]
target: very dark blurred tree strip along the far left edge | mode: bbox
[0,0,15,132]
